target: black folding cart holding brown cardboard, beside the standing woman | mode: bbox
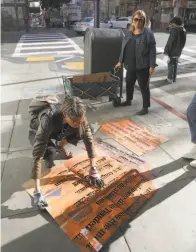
[62,69,121,107]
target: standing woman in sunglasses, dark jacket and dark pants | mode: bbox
[116,10,156,115]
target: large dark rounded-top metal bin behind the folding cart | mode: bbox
[84,28,124,97]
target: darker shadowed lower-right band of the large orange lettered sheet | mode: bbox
[66,170,155,251]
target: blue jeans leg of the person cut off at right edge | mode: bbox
[187,94,196,144]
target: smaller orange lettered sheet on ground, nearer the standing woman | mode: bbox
[100,120,168,155]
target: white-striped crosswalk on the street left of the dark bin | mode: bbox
[12,33,83,61]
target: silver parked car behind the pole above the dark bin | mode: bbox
[73,17,111,34]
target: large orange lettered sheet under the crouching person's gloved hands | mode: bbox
[24,154,156,252]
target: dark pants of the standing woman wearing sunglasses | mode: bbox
[126,68,150,108]
